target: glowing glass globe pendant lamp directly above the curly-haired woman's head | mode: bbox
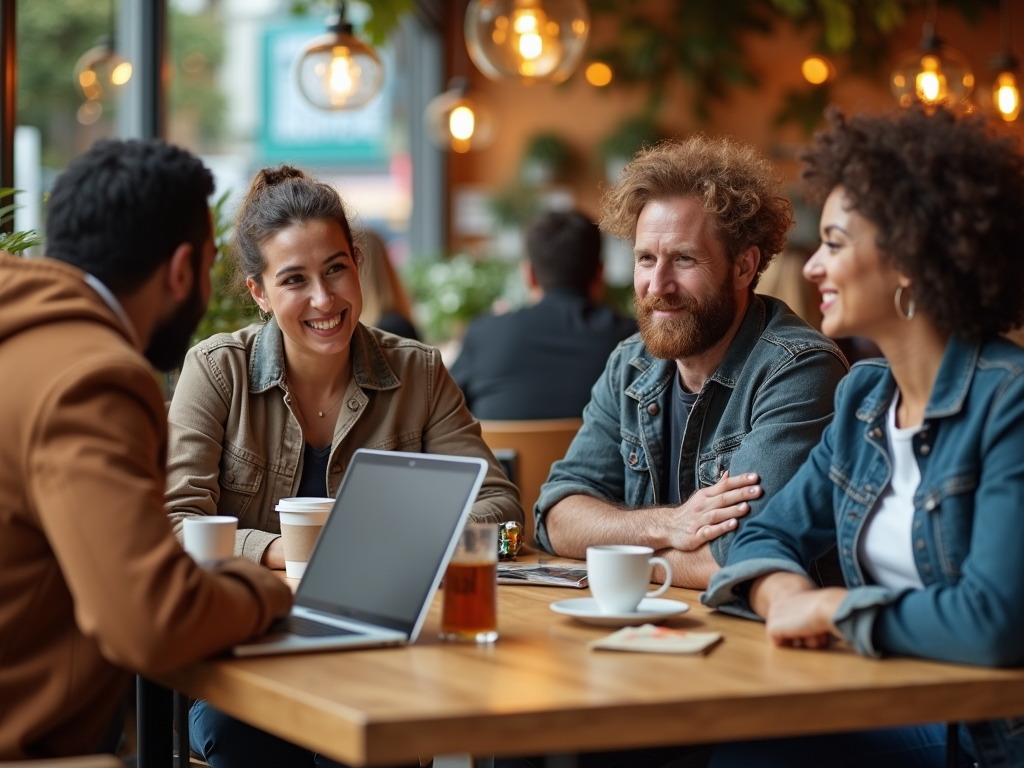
[889,23,974,109]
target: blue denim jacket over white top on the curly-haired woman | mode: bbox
[702,337,1024,766]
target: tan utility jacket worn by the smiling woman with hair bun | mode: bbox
[166,319,523,562]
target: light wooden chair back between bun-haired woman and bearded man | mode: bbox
[480,419,583,544]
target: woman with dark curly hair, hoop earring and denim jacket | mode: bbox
[703,103,1024,768]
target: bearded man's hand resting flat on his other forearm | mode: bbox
[664,471,764,552]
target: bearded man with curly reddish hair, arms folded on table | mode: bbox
[535,136,848,588]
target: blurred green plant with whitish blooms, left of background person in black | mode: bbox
[402,254,516,341]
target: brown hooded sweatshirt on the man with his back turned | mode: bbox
[0,254,291,760]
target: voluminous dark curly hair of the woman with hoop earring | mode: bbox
[802,106,1024,339]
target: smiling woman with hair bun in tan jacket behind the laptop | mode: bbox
[166,166,523,768]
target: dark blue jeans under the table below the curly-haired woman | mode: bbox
[709,724,974,768]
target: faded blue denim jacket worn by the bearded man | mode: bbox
[535,294,848,564]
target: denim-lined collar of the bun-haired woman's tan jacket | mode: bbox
[249,317,401,393]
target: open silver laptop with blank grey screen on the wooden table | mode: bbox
[231,449,487,656]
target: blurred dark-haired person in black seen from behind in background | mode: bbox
[452,211,636,420]
